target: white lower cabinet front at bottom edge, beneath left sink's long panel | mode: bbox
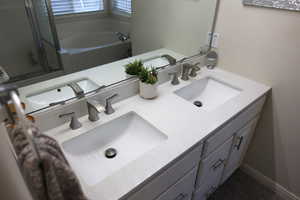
[156,167,197,200]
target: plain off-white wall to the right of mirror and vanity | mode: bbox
[217,0,300,196]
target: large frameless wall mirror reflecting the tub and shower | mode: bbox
[0,0,218,113]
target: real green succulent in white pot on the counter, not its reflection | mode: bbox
[139,66,158,99]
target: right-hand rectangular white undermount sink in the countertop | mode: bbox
[175,77,242,111]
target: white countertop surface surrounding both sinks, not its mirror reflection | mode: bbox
[46,69,270,200]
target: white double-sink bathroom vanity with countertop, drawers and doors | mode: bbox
[46,68,270,200]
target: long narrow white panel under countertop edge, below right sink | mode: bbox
[203,97,265,157]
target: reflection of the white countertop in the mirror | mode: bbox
[19,49,184,113]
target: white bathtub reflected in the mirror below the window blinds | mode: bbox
[61,32,131,72]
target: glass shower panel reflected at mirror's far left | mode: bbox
[0,0,44,81]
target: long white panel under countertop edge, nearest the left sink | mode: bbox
[126,145,202,200]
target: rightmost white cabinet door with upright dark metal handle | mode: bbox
[222,118,258,183]
